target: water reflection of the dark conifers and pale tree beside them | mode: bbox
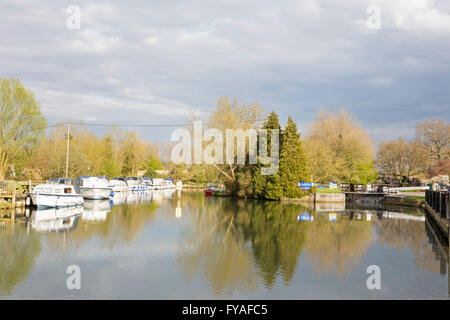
[178,198,307,295]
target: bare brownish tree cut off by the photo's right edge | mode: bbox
[416,120,450,161]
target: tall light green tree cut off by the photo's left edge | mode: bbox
[0,79,47,180]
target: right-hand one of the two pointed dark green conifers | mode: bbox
[280,116,311,198]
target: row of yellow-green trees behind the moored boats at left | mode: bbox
[0,79,162,180]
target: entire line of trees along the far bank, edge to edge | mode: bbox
[0,79,450,199]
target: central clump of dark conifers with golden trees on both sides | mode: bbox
[173,98,377,200]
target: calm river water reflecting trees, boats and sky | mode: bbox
[0,191,449,299]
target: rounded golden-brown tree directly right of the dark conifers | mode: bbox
[307,109,377,183]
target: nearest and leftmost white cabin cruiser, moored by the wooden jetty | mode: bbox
[31,178,83,209]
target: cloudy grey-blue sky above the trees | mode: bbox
[0,0,450,142]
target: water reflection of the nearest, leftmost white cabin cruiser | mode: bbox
[31,207,83,232]
